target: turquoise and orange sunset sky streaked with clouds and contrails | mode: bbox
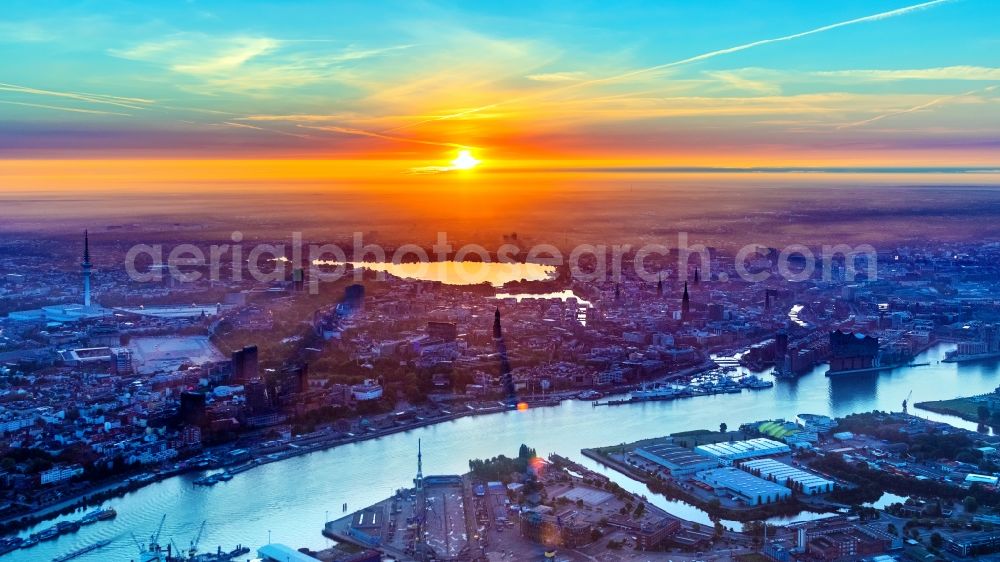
[0,0,1000,187]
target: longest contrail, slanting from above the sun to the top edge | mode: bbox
[387,0,954,132]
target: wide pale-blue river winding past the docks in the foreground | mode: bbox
[9,345,1000,562]
